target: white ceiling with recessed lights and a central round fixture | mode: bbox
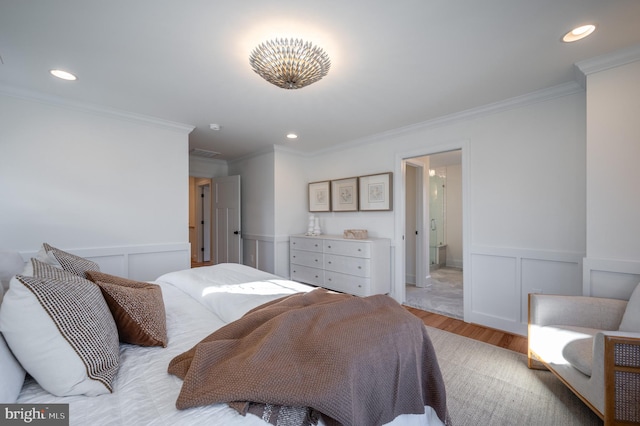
[0,0,640,160]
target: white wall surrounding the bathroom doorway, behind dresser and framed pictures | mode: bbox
[301,87,586,334]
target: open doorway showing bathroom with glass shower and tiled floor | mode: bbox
[405,150,464,319]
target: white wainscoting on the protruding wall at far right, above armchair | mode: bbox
[582,257,640,300]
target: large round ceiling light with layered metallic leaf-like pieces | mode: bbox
[249,38,331,89]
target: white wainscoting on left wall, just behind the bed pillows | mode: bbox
[20,242,191,281]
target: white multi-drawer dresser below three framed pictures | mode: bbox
[289,235,391,296]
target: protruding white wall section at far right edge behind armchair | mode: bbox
[584,60,640,299]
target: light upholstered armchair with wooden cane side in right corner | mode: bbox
[528,284,640,425]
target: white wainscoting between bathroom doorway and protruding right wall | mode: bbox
[465,246,584,336]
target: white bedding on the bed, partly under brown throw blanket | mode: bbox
[17,264,442,426]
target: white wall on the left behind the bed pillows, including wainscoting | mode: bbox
[0,92,190,280]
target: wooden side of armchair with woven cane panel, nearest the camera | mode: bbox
[594,332,640,425]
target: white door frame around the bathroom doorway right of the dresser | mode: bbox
[391,139,472,321]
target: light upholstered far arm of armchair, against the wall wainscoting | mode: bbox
[529,294,627,330]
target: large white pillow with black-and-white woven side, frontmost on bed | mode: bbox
[0,266,119,396]
